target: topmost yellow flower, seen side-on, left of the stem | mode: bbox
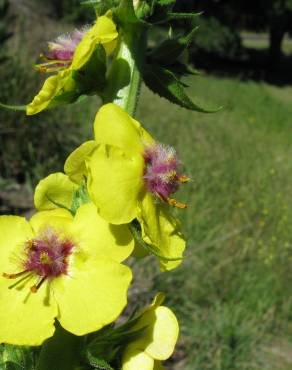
[26,13,118,115]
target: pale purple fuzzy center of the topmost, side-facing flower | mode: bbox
[36,26,90,73]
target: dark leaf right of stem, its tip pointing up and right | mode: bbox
[148,27,198,65]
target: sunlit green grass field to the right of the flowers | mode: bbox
[137,77,292,370]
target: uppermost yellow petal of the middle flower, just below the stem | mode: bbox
[94,103,149,154]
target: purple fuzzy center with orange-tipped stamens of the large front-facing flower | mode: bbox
[3,228,74,293]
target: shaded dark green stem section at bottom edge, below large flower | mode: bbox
[36,324,82,370]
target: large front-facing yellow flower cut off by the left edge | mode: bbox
[0,203,133,345]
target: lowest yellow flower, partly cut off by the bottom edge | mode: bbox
[122,293,179,370]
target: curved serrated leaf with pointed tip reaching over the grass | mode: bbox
[143,64,222,113]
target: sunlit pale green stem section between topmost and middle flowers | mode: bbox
[104,25,146,116]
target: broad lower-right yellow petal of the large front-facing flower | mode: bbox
[52,255,132,335]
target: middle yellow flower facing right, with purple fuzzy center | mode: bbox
[64,103,187,270]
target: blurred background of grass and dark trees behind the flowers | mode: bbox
[0,0,292,370]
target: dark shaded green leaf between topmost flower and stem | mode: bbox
[72,44,106,94]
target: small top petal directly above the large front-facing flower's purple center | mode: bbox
[30,208,73,236]
